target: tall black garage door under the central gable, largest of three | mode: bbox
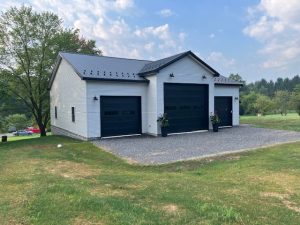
[164,84,209,133]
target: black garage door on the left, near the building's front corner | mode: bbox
[100,96,142,137]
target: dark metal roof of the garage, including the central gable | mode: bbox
[48,51,242,89]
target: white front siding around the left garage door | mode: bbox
[86,81,148,138]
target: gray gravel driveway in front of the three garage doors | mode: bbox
[93,125,300,165]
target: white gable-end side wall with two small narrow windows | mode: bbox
[50,59,87,137]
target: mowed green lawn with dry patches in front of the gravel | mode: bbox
[0,136,300,225]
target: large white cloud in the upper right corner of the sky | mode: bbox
[243,0,300,68]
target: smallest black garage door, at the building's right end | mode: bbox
[215,97,232,126]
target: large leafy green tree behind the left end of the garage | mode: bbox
[0,6,101,136]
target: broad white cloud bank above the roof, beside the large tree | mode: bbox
[0,0,186,59]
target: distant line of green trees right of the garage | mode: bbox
[229,74,300,115]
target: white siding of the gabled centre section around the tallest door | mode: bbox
[157,56,214,133]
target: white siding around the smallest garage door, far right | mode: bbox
[215,86,240,126]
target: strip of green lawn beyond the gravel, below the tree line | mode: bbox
[240,113,300,131]
